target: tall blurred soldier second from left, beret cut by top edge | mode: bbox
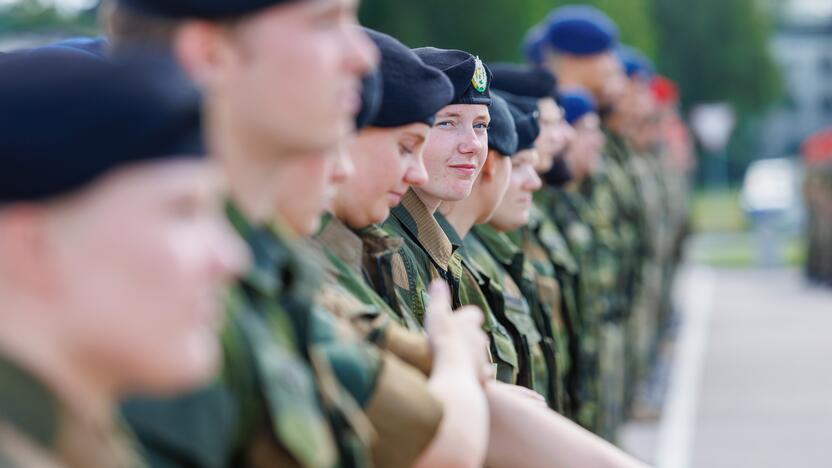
[108,0,394,467]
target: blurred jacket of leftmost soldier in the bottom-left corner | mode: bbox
[0,356,145,468]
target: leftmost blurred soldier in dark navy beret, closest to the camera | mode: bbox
[0,47,246,468]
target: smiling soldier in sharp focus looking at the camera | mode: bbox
[376,48,519,383]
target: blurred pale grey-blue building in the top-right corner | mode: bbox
[759,0,832,158]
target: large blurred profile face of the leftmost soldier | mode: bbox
[46,159,248,393]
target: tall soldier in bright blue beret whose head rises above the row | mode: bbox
[531,6,640,439]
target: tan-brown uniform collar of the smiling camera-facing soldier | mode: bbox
[392,189,454,271]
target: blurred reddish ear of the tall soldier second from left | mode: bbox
[173,20,228,90]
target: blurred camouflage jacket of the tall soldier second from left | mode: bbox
[125,207,372,467]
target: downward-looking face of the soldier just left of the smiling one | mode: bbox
[333,123,430,228]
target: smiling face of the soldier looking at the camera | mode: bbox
[418,104,491,207]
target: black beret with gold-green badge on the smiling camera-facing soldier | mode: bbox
[414,47,492,106]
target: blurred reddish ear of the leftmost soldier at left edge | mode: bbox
[0,205,55,296]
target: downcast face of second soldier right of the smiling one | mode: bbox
[491,149,543,232]
